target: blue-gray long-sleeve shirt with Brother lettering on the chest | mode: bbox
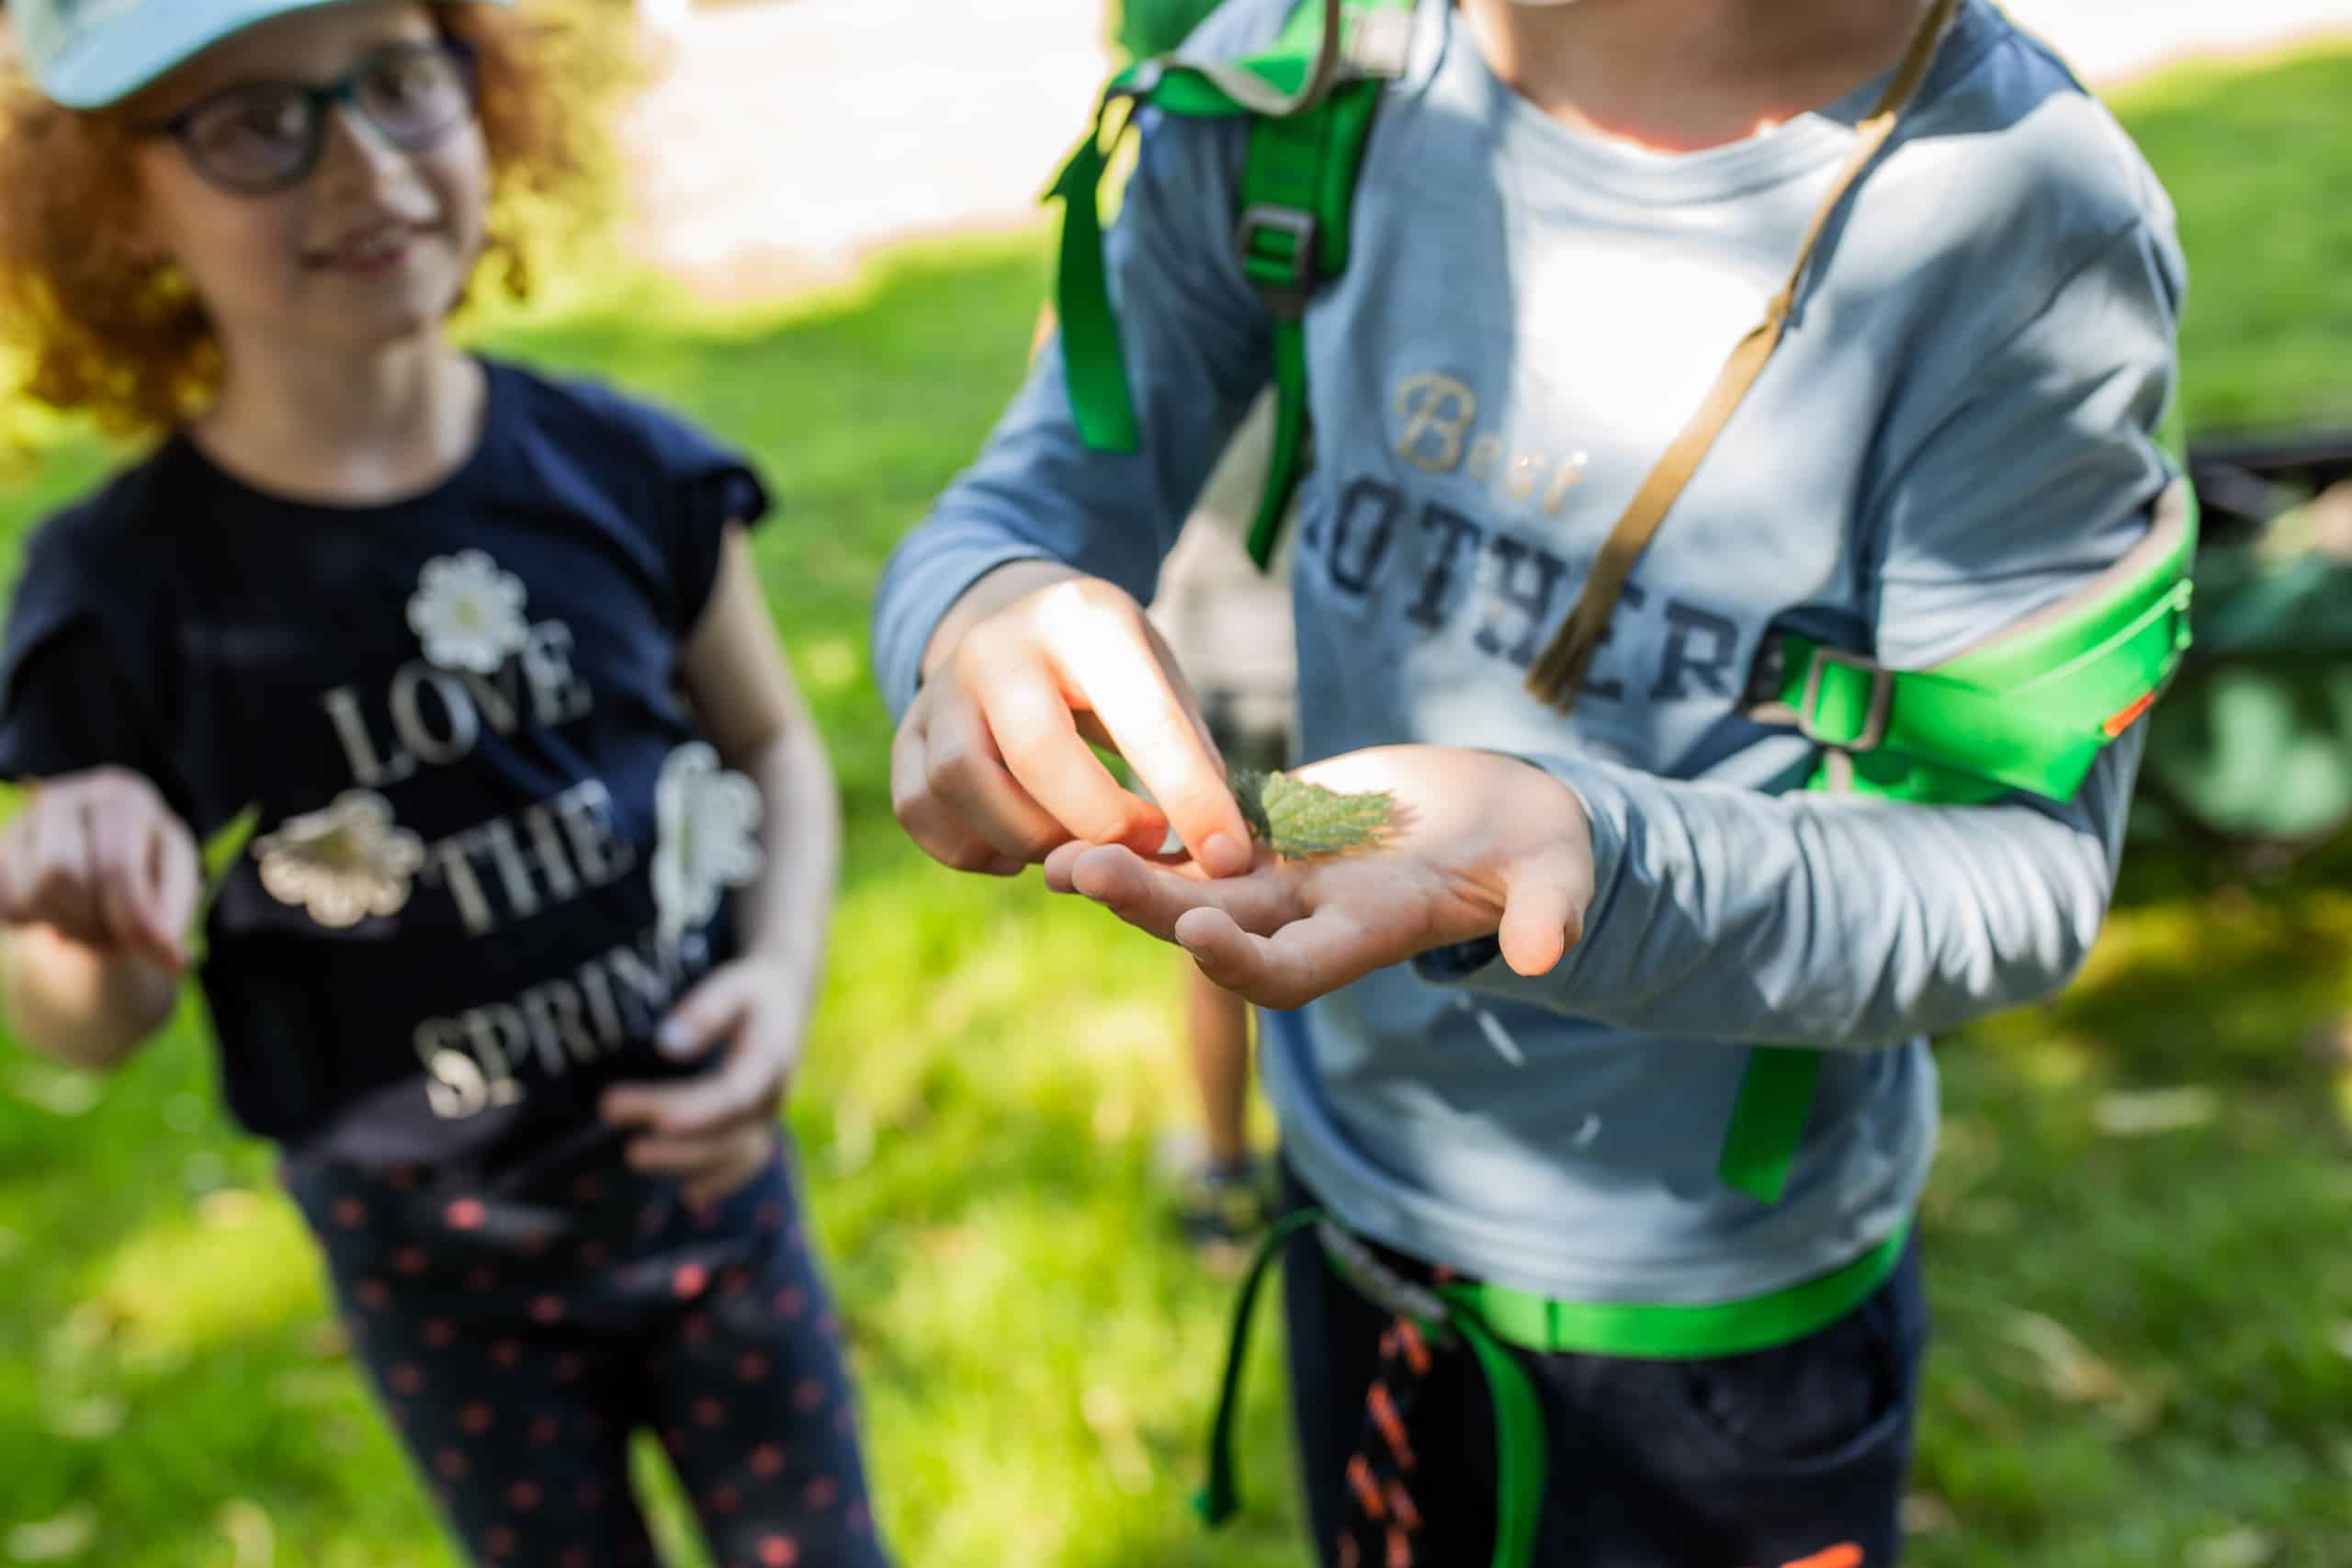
[875,0,2185,1303]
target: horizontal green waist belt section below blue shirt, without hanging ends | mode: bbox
[1437,1224,1910,1359]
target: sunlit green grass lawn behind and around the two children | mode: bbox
[0,33,2352,1568]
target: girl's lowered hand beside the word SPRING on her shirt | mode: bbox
[605,952,811,1206]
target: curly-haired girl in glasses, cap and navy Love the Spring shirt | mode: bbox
[0,0,885,1568]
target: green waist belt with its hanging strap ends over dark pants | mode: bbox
[1193,1208,1910,1568]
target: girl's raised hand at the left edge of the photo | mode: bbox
[0,766,205,974]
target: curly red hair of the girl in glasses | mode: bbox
[0,0,628,434]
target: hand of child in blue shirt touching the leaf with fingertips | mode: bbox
[891,562,1249,877]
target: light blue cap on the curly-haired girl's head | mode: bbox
[7,0,513,108]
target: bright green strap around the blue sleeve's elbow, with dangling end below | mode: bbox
[1717,402,2199,1203]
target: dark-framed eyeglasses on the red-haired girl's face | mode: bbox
[143,38,480,195]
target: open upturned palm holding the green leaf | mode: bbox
[1045,745,1592,1009]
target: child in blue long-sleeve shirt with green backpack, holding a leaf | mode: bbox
[875,0,2192,1568]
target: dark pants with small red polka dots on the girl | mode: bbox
[285,1145,889,1568]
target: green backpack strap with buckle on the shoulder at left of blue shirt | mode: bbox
[1051,0,1414,569]
